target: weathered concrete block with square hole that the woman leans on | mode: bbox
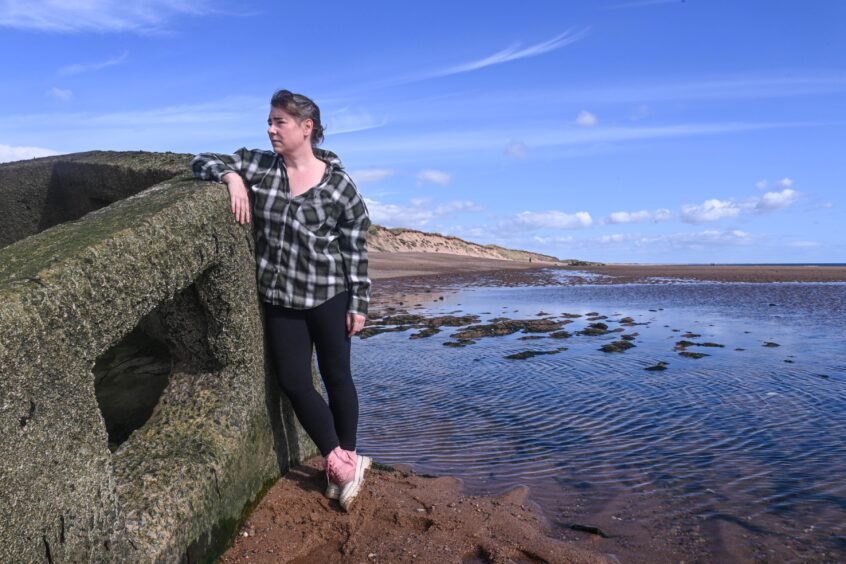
[0,153,314,562]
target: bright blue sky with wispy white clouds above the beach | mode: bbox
[0,0,846,263]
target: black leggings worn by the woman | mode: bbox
[264,292,358,456]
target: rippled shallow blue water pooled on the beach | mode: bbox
[353,280,846,561]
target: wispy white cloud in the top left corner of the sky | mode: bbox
[0,0,210,33]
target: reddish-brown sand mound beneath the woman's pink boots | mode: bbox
[220,457,613,564]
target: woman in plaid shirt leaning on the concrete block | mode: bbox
[191,90,371,511]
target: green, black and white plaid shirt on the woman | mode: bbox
[191,148,370,315]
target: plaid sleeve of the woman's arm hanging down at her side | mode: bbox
[338,181,370,316]
